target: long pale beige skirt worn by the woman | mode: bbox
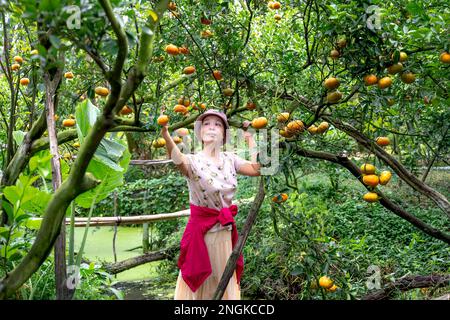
[174,230,241,300]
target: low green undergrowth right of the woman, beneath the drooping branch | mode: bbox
[240,175,450,299]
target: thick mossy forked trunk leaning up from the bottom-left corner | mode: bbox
[0,0,168,299]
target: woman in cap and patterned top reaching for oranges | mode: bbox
[161,110,260,300]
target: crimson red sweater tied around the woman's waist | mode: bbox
[178,204,244,292]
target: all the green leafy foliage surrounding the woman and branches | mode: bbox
[0,0,450,299]
